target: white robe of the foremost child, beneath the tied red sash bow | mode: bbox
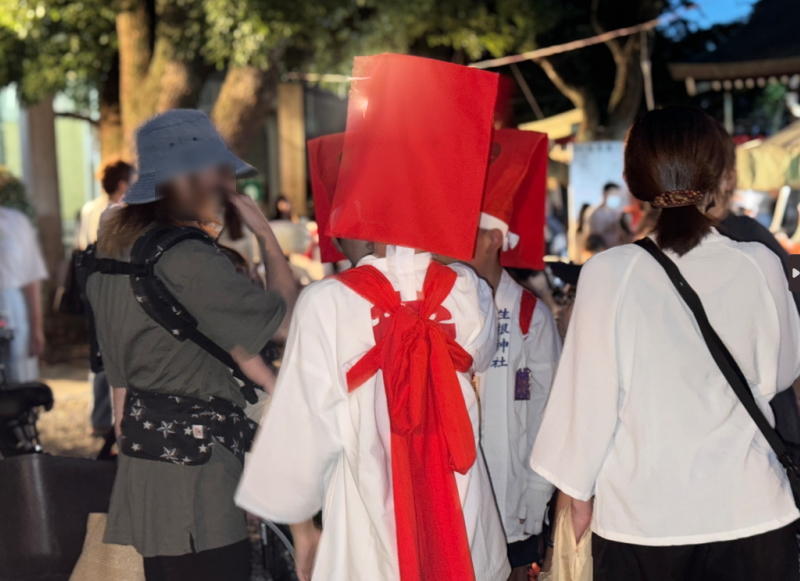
[236,254,510,581]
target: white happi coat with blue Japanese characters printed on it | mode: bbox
[477,271,561,543]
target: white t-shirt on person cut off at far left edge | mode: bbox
[0,207,47,290]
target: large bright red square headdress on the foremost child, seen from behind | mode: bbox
[328,54,498,260]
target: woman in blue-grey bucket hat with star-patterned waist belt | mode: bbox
[87,110,296,581]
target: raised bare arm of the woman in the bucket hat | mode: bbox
[228,193,298,341]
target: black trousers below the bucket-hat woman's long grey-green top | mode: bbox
[144,539,250,581]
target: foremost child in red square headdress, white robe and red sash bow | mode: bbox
[237,55,510,581]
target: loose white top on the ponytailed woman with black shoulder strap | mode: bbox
[531,231,800,545]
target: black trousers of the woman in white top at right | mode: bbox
[592,524,800,581]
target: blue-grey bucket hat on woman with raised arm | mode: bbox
[122,109,256,204]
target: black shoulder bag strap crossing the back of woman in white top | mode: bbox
[635,238,800,507]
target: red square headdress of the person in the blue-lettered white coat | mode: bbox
[480,129,549,270]
